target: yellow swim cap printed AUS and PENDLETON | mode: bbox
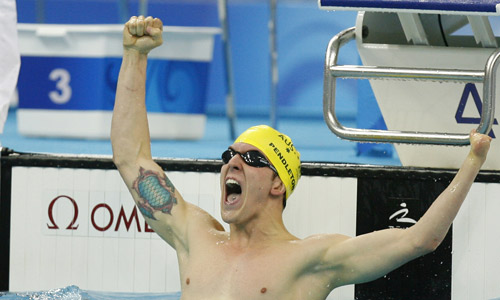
[234,125,300,199]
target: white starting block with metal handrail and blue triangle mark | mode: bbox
[319,0,500,170]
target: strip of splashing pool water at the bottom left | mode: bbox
[0,285,181,300]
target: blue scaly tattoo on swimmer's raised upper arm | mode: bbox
[133,167,177,220]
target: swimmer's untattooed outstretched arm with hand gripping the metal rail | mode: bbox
[317,131,491,286]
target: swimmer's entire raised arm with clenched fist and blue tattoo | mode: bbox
[111,17,224,251]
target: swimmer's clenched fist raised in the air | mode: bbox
[123,16,163,54]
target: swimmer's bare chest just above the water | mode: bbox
[181,243,324,300]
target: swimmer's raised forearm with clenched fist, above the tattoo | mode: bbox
[111,17,163,186]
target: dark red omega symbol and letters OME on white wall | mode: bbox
[47,195,154,232]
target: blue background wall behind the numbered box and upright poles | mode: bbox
[17,0,359,120]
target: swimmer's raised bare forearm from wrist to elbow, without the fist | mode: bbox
[111,50,151,163]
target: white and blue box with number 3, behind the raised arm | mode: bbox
[17,24,220,140]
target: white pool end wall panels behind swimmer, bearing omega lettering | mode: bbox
[10,167,500,300]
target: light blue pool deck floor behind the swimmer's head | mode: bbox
[0,109,401,166]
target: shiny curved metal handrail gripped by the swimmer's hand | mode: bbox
[323,27,500,146]
